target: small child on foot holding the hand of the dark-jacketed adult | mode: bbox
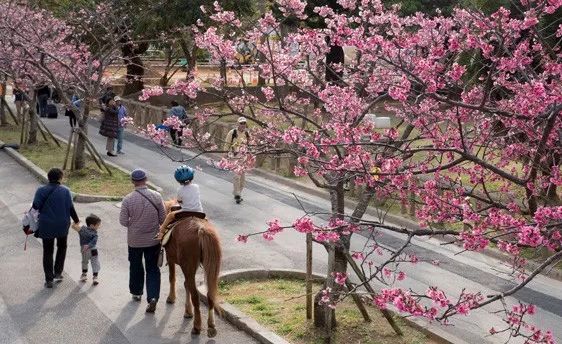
[72,214,101,285]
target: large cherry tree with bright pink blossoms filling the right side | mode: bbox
[141,0,562,343]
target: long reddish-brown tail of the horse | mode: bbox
[199,222,222,313]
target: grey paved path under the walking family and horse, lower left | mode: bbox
[0,151,256,344]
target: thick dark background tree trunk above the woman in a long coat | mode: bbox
[121,42,148,96]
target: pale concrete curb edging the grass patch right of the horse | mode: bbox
[197,269,458,344]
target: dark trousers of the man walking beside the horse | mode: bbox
[129,245,160,301]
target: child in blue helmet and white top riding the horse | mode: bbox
[156,165,203,240]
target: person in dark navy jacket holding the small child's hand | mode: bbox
[33,168,80,288]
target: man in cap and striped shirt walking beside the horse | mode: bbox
[119,169,166,313]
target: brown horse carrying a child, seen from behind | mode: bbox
[165,200,222,337]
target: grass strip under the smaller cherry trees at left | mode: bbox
[0,124,132,196]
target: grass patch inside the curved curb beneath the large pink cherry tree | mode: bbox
[220,279,437,344]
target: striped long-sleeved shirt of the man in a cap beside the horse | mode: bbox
[119,186,166,247]
